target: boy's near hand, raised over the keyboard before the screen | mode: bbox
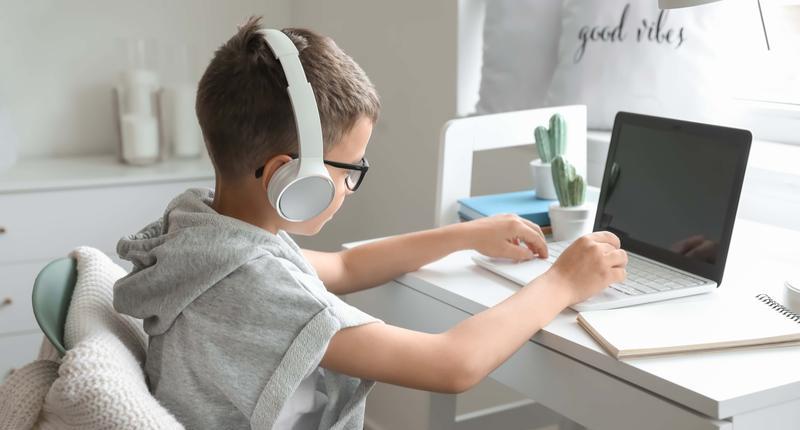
[543,231,628,305]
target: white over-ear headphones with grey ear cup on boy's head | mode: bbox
[258,29,336,222]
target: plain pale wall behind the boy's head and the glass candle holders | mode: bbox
[0,0,512,245]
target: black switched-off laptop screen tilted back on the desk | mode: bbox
[595,113,750,282]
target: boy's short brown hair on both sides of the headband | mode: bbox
[195,17,380,179]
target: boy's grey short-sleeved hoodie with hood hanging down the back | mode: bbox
[114,188,377,429]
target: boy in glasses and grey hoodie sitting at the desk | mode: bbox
[114,19,627,429]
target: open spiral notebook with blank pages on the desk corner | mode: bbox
[578,294,800,358]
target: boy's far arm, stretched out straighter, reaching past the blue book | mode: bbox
[303,215,547,294]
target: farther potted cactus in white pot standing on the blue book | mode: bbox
[530,114,567,200]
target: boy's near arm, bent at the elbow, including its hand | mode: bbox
[321,233,627,393]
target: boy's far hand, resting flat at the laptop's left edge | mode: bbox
[461,214,547,261]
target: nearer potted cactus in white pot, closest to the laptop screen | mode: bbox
[549,156,593,241]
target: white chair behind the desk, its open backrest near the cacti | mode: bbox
[429,105,586,430]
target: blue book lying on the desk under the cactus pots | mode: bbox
[458,190,558,226]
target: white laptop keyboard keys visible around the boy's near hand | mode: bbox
[547,242,707,296]
